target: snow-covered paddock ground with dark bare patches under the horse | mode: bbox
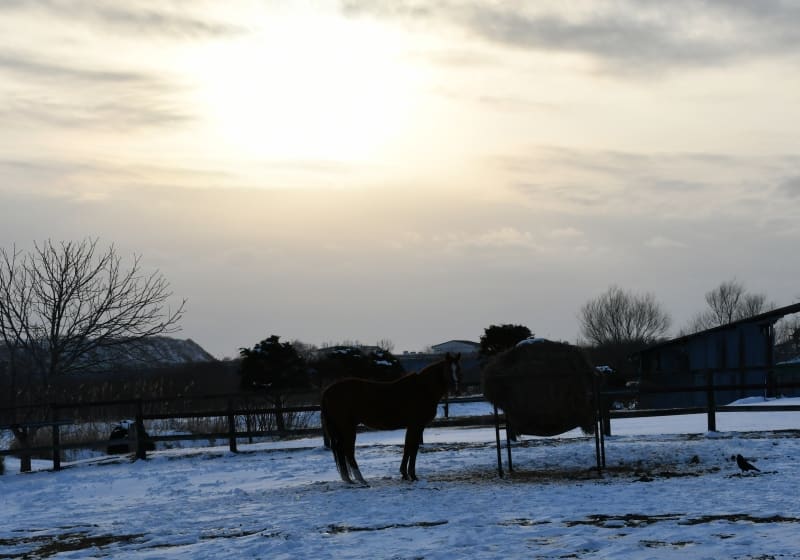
[0,399,800,560]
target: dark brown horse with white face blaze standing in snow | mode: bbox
[321,353,461,484]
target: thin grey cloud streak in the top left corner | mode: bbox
[0,0,245,39]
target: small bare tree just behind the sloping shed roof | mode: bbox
[689,279,775,332]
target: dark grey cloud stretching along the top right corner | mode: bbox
[344,0,800,74]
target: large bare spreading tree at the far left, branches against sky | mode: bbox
[0,240,186,467]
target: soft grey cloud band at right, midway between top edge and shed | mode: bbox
[504,146,791,220]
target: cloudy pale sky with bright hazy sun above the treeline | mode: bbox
[0,0,800,358]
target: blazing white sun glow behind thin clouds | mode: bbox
[179,13,421,162]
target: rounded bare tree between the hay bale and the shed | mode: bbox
[579,286,671,346]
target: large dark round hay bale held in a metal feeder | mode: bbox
[482,339,595,436]
